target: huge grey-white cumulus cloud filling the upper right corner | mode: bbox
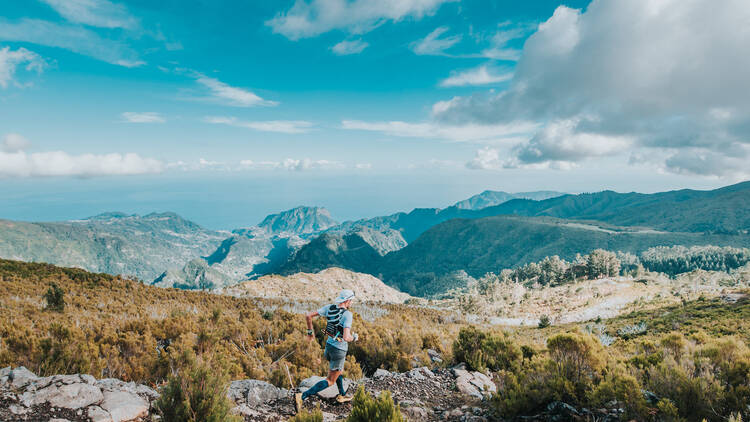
[433,0,750,174]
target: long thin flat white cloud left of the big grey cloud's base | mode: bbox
[341,120,537,141]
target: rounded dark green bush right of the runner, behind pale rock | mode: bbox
[453,327,521,371]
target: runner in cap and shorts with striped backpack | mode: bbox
[294,289,358,412]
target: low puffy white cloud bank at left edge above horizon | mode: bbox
[0,134,165,177]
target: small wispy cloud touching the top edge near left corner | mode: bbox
[41,0,138,29]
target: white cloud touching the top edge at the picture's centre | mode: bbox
[266,0,457,40]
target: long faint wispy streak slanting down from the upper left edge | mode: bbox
[0,18,145,67]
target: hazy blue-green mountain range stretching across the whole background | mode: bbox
[0,182,750,295]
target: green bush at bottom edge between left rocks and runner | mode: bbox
[156,357,240,422]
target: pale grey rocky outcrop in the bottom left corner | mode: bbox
[0,367,159,422]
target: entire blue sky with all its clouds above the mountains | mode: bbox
[0,0,750,229]
